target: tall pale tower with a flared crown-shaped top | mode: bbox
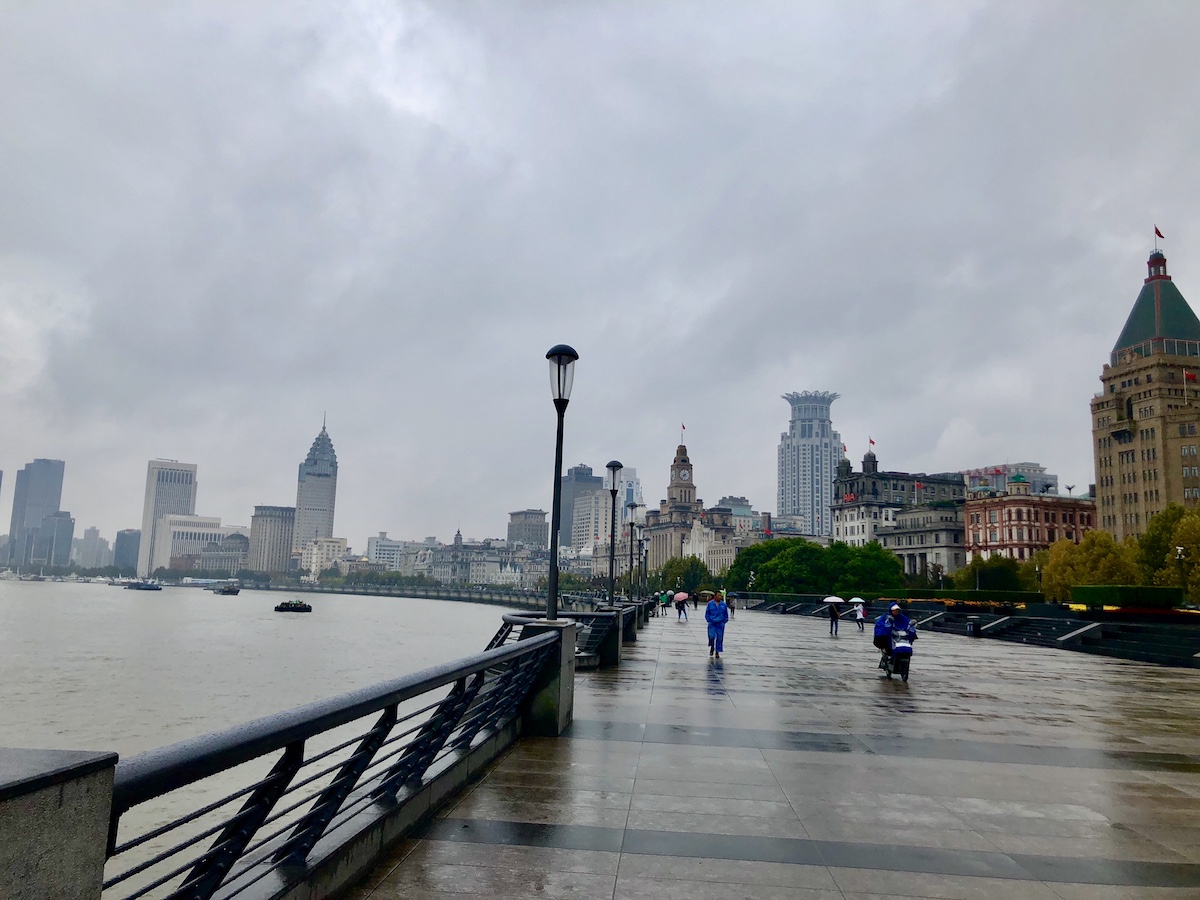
[775,391,842,535]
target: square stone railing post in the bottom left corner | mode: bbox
[0,749,116,900]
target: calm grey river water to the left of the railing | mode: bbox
[0,581,505,757]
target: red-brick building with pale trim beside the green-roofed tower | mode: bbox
[962,475,1096,562]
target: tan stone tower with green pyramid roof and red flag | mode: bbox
[1091,250,1200,541]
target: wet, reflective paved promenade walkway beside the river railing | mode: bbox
[353,610,1200,900]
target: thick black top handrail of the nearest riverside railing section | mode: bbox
[113,617,558,818]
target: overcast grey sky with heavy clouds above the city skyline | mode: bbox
[0,0,1200,550]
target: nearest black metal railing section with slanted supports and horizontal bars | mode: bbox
[103,623,559,900]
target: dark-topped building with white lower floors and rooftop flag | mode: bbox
[833,450,966,547]
